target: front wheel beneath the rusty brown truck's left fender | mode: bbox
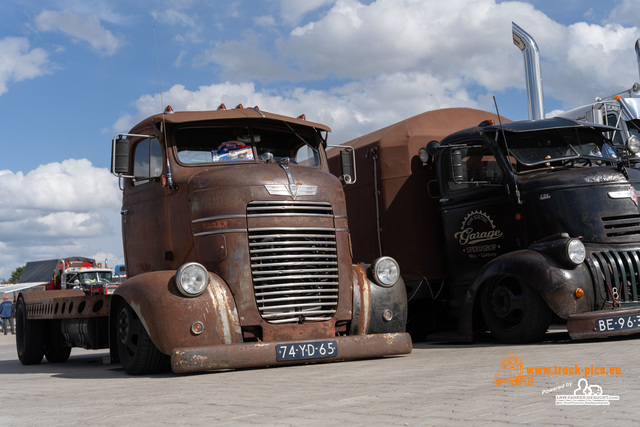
[116,301,169,375]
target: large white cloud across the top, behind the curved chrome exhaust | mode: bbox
[207,0,639,113]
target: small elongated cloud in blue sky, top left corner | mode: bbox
[35,10,123,55]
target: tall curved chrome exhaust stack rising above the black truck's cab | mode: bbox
[511,22,544,120]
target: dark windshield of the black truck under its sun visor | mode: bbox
[507,128,617,166]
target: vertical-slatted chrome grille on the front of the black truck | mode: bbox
[589,251,640,306]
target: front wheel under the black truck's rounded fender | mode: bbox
[481,277,553,344]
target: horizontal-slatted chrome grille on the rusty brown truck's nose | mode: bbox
[247,201,338,323]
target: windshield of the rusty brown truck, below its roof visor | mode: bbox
[174,126,321,167]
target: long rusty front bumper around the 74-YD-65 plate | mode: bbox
[171,333,411,373]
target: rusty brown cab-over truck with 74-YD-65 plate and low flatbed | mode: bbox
[17,106,411,374]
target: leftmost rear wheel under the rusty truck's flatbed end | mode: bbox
[16,297,44,365]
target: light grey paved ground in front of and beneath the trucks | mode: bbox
[0,331,640,427]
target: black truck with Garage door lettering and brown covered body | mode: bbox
[329,108,640,343]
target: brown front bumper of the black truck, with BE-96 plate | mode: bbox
[567,307,640,340]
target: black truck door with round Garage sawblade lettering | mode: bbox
[439,141,519,287]
